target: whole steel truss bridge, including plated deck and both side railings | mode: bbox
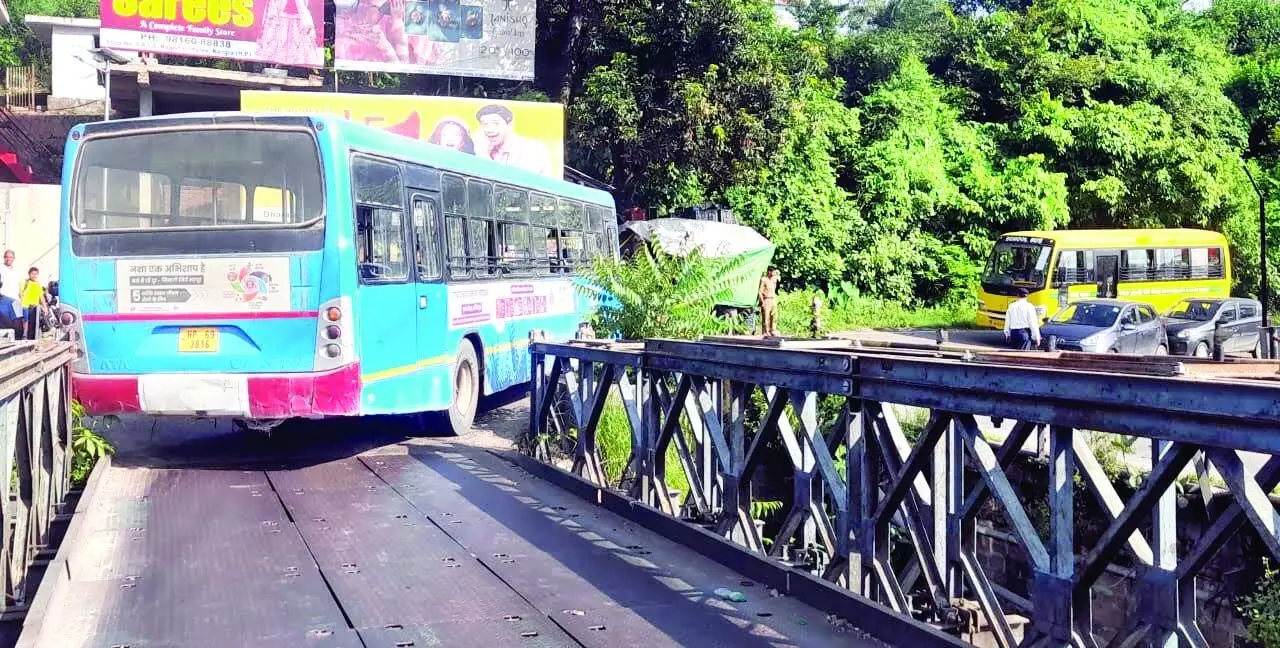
[0,339,1280,648]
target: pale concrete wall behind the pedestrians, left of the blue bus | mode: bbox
[0,183,61,283]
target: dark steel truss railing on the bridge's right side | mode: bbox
[522,341,1280,648]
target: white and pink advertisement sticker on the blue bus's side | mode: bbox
[449,280,575,328]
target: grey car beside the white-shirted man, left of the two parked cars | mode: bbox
[1041,300,1169,356]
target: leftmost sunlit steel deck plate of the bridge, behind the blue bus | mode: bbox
[35,467,353,648]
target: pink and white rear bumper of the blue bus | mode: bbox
[72,364,360,419]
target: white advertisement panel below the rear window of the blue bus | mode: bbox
[115,256,289,312]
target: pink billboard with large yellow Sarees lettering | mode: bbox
[100,0,324,68]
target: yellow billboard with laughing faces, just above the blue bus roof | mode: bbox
[241,90,564,179]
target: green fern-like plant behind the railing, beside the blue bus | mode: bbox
[580,246,750,339]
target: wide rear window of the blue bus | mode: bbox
[72,129,324,233]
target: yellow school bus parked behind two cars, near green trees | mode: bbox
[978,229,1231,328]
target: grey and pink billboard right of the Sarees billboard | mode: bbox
[333,0,538,81]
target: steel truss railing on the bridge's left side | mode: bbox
[0,342,76,617]
